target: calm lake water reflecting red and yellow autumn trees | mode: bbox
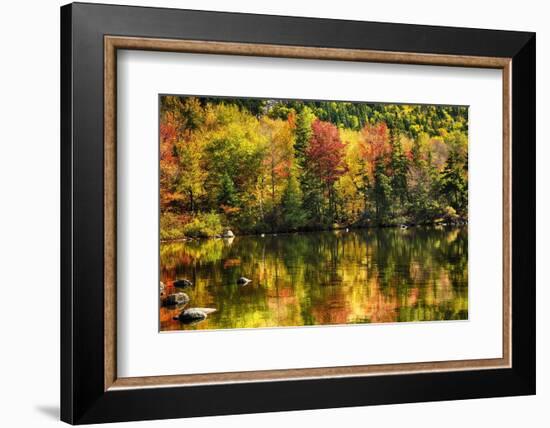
[160,227,468,330]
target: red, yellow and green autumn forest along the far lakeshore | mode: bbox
[160,96,468,239]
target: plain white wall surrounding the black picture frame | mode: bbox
[0,0,550,428]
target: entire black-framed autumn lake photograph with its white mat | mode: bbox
[61,3,535,424]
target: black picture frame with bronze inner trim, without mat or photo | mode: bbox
[61,3,535,424]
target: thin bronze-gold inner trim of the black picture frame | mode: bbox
[104,36,512,391]
